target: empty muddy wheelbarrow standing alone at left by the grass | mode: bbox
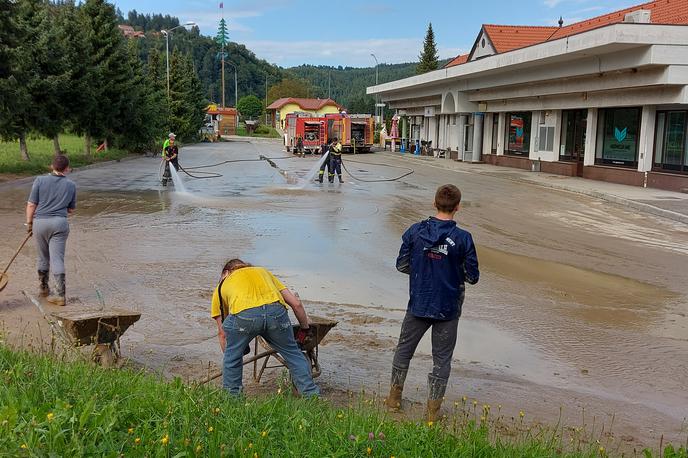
[24,292,141,367]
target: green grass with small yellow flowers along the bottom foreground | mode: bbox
[0,346,688,458]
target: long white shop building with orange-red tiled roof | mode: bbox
[368,0,688,191]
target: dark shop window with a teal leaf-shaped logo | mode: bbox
[595,107,641,167]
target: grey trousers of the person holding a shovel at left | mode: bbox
[33,216,69,275]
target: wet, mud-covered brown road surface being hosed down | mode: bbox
[0,142,688,447]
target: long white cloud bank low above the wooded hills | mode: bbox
[244,38,468,67]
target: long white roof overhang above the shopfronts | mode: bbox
[367,23,688,101]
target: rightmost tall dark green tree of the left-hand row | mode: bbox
[169,49,207,141]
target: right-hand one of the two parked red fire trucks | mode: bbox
[325,113,375,153]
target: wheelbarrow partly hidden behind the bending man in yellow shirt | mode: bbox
[201,317,337,384]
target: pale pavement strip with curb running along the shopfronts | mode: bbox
[386,153,688,224]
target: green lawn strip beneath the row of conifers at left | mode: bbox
[0,134,128,175]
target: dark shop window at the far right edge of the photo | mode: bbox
[654,111,688,173]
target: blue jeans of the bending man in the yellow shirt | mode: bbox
[222,302,320,396]
